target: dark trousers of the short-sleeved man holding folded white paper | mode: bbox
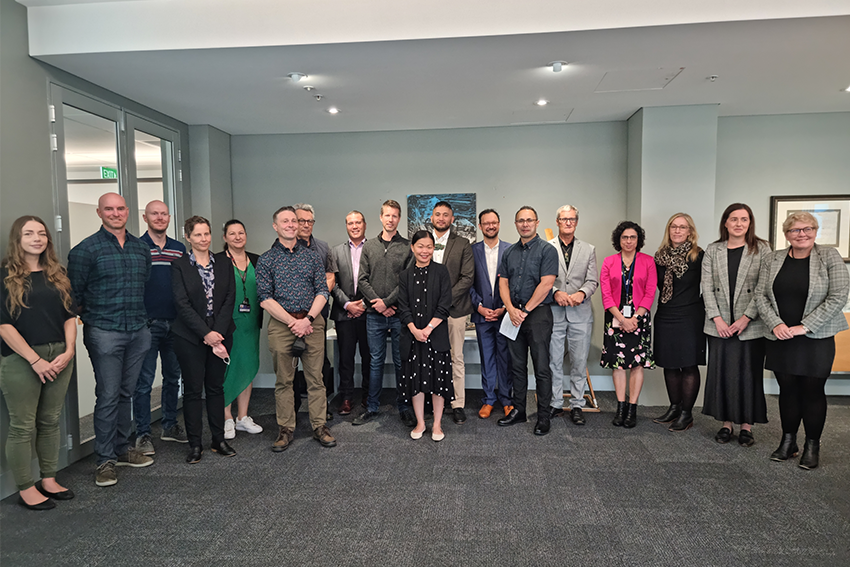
[505,305,552,418]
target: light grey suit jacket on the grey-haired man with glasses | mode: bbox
[549,236,599,323]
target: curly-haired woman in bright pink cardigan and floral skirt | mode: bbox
[599,221,658,428]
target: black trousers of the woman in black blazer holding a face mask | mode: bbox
[174,336,231,447]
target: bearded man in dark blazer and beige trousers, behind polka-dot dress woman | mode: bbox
[431,201,475,425]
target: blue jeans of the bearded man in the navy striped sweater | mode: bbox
[133,319,180,437]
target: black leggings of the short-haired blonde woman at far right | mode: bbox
[774,371,827,440]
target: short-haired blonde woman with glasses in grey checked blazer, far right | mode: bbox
[756,212,850,469]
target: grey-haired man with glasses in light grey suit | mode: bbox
[549,205,599,425]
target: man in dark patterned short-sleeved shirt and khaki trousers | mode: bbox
[256,207,336,452]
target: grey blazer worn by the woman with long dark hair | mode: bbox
[702,241,771,341]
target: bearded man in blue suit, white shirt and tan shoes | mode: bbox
[469,209,513,419]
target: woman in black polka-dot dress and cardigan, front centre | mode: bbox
[398,230,454,441]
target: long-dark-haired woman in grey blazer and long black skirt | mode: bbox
[702,203,770,447]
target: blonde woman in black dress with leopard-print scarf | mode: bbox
[653,213,705,431]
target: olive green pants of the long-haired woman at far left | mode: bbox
[0,343,74,490]
